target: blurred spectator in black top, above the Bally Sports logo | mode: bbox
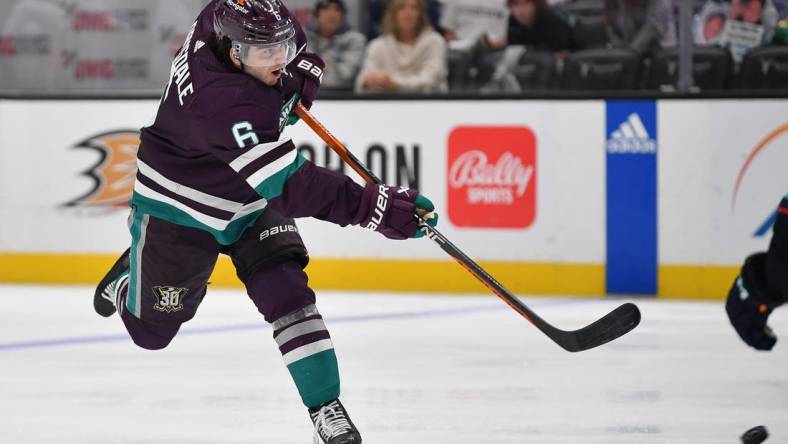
[506,0,572,56]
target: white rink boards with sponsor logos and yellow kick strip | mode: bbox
[0,99,788,298]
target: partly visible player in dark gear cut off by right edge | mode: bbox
[725,195,788,350]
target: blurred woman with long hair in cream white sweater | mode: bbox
[356,0,448,92]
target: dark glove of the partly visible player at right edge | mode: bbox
[725,253,783,350]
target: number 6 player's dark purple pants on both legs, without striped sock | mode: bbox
[120,210,315,349]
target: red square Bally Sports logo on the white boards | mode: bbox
[448,126,537,228]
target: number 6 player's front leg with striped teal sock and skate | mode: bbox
[230,211,361,444]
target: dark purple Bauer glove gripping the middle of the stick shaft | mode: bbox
[353,183,438,239]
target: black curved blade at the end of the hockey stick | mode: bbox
[553,302,640,352]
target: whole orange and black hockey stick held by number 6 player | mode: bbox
[295,103,640,352]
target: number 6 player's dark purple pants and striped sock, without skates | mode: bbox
[118,210,340,407]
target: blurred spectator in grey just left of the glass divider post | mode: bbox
[605,0,677,53]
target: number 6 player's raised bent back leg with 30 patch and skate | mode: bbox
[94,211,219,350]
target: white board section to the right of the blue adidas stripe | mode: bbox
[659,100,788,265]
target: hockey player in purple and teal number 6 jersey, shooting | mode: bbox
[94,0,437,444]
